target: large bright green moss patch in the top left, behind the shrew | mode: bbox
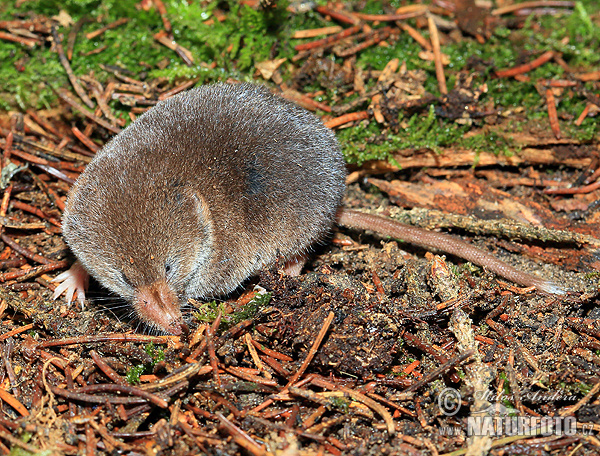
[0,0,292,111]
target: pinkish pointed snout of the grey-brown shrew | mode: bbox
[133,280,183,336]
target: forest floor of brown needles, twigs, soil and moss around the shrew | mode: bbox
[0,0,600,455]
